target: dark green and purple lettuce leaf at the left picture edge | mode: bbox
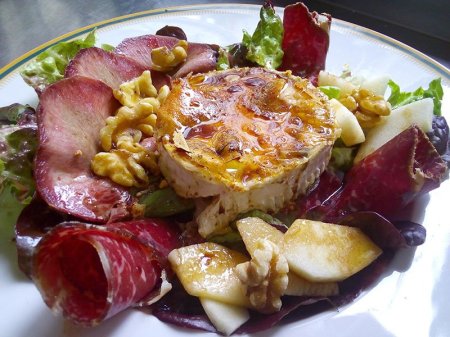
[0,104,37,204]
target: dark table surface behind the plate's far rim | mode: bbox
[0,0,450,68]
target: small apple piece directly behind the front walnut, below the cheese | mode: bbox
[236,217,283,253]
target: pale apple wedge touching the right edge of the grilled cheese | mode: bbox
[330,98,366,146]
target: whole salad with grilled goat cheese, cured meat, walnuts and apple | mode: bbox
[1,2,448,334]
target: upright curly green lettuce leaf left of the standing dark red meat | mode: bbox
[242,6,284,69]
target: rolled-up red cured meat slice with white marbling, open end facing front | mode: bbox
[32,219,179,326]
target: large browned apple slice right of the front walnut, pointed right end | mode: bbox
[283,219,381,282]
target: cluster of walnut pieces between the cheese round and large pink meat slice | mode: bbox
[91,70,170,187]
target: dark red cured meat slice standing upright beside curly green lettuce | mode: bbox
[281,3,331,84]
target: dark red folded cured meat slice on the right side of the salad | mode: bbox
[314,126,448,221]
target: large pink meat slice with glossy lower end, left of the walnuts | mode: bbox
[34,76,131,222]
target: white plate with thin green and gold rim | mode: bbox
[0,4,450,337]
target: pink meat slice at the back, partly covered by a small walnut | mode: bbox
[115,35,217,77]
